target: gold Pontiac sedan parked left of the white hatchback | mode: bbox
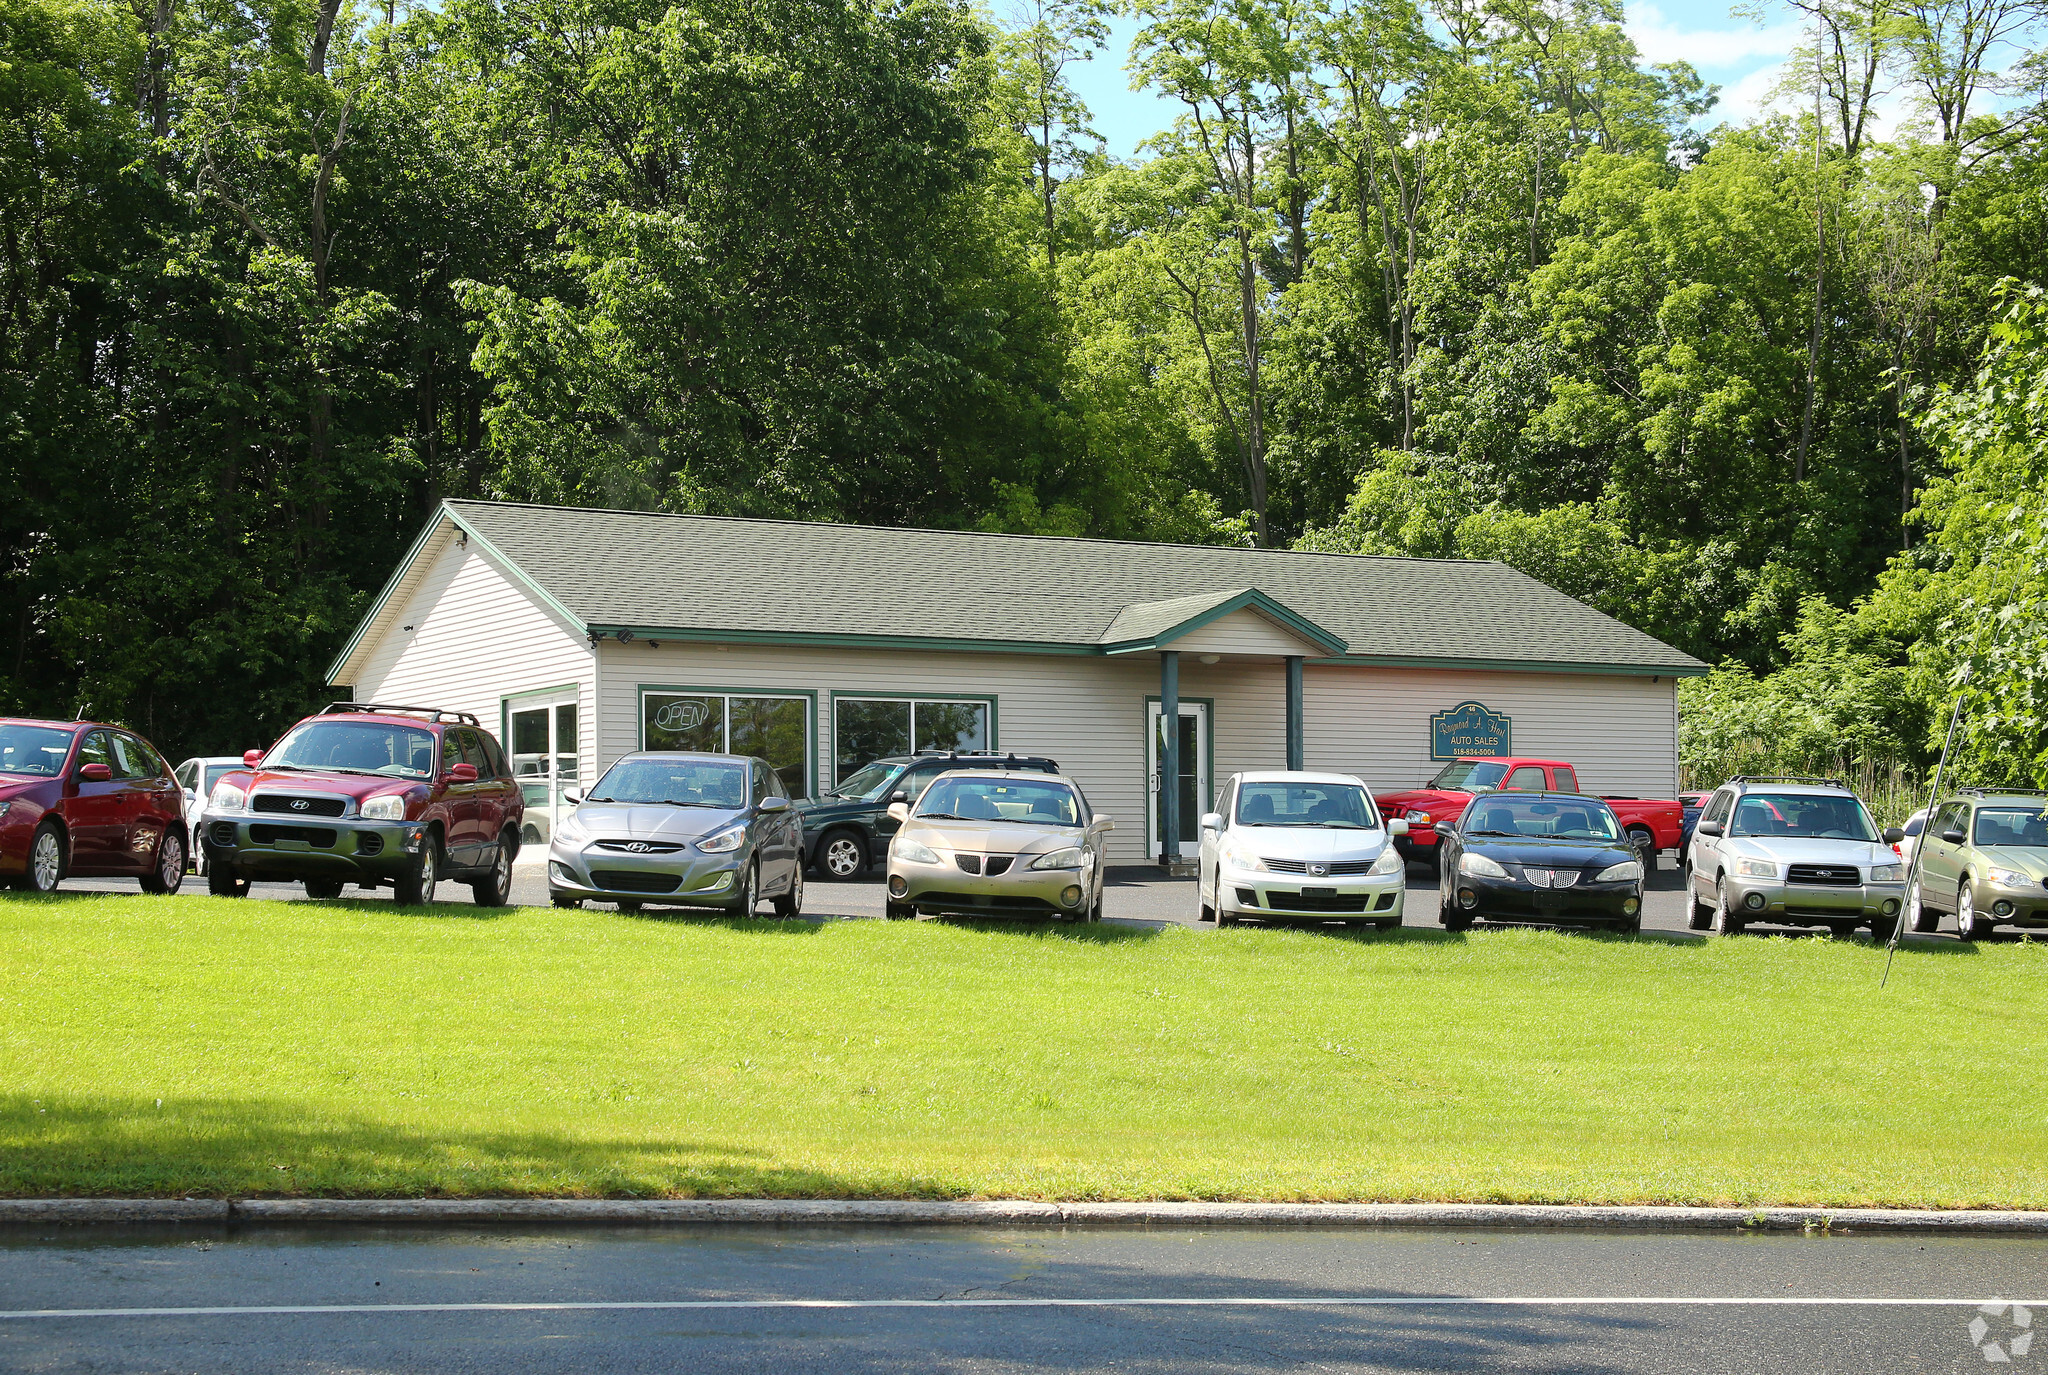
[887,768,1110,922]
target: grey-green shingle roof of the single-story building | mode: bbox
[436,500,1706,674]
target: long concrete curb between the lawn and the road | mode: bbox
[0,1199,2048,1236]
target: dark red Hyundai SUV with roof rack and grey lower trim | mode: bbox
[201,703,526,908]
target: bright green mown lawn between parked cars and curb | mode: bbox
[0,895,2048,1207]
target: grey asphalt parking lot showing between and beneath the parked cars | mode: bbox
[66,855,1982,941]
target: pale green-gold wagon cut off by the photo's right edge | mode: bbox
[1907,787,2048,941]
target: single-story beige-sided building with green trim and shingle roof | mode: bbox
[328,500,1706,863]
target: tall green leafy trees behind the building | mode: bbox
[0,0,2048,766]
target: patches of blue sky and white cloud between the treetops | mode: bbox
[1067,0,1835,158]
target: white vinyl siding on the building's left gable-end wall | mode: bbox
[350,539,596,779]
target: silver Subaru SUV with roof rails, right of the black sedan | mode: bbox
[1686,777,1907,941]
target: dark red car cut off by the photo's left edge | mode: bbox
[0,717,186,893]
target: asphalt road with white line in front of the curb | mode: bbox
[0,1227,2048,1375]
